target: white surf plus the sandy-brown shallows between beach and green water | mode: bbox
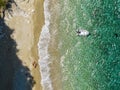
[39,0,62,90]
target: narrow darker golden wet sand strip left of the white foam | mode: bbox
[31,0,44,90]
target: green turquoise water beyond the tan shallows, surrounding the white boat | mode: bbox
[39,0,120,90]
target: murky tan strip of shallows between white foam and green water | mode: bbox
[48,0,62,90]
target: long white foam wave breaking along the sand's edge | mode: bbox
[38,0,53,90]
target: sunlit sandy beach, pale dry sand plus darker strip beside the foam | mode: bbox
[5,0,44,90]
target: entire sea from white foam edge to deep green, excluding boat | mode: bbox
[39,0,120,90]
